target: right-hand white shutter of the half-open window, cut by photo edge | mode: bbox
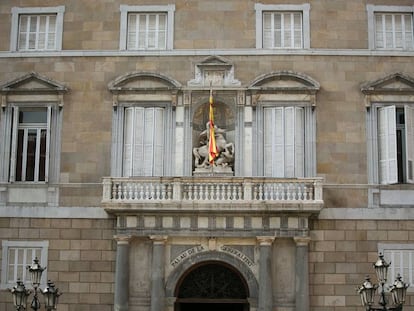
[404,105,414,184]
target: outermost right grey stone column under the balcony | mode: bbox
[294,237,310,311]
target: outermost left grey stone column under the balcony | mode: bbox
[114,235,131,311]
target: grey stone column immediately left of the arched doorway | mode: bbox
[150,235,167,311]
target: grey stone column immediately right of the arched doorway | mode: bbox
[257,236,275,311]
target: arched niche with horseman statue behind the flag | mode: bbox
[193,104,235,176]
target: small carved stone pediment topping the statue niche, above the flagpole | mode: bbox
[187,56,241,87]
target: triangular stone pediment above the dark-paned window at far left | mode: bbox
[0,72,68,93]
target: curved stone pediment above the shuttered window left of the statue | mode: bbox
[108,72,181,92]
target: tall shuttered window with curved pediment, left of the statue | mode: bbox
[108,72,181,177]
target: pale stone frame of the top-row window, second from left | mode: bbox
[119,4,175,51]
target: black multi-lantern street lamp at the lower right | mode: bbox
[357,253,409,311]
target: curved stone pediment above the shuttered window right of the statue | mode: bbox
[249,71,320,94]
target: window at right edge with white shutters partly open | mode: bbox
[378,105,414,184]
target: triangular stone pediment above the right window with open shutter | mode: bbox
[361,72,414,94]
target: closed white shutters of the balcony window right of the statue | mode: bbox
[263,107,304,177]
